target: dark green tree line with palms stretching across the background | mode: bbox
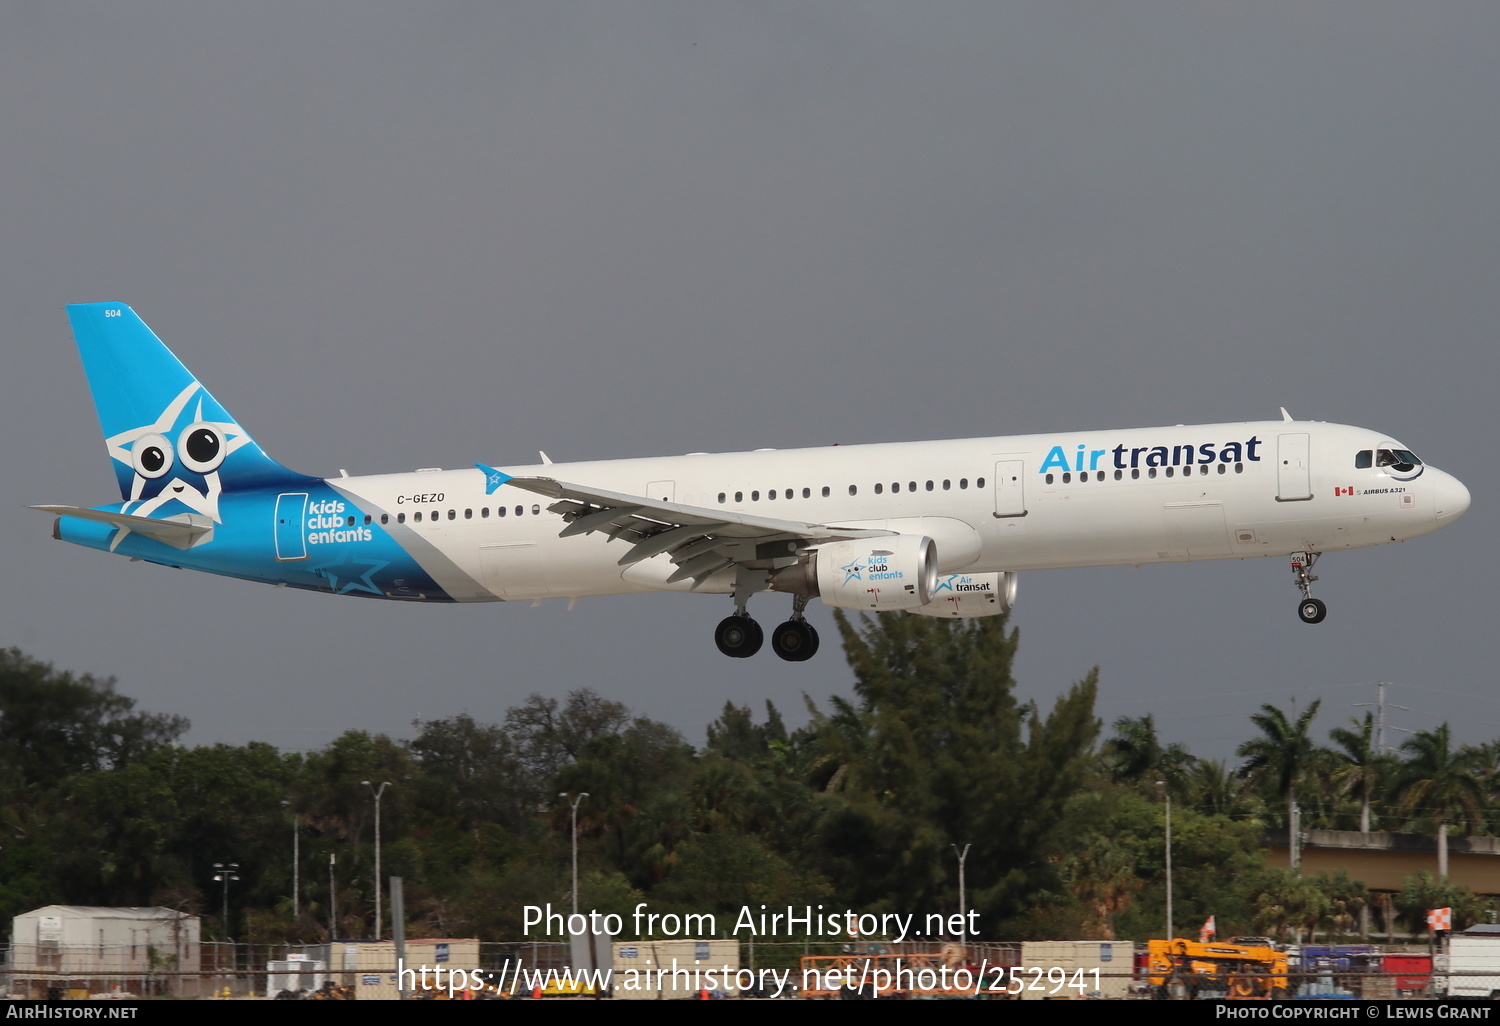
[0,614,1500,944]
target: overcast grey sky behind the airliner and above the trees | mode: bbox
[0,0,1500,756]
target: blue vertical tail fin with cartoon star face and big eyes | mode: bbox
[68,303,311,519]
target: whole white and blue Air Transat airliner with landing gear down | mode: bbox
[35,303,1469,662]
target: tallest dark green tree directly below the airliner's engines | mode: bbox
[815,614,1100,936]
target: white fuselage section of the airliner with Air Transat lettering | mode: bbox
[329,422,1469,602]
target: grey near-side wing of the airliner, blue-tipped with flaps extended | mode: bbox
[504,468,894,587]
